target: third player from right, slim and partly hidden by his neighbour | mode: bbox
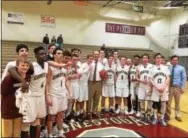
[129,55,140,114]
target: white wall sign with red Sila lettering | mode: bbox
[41,15,55,28]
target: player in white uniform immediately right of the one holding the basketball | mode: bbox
[116,56,129,115]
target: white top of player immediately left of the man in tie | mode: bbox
[78,62,90,85]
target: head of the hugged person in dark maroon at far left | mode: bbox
[16,58,30,74]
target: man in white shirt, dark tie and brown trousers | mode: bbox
[87,51,104,117]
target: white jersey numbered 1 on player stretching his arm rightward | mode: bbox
[50,66,67,97]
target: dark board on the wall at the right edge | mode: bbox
[178,24,188,48]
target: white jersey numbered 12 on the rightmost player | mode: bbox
[150,65,170,89]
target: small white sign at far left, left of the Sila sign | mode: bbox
[7,12,24,25]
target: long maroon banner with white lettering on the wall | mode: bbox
[105,23,146,35]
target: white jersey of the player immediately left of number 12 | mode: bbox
[138,63,153,86]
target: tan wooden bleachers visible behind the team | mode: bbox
[1,40,155,71]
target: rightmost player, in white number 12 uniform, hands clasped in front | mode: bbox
[149,53,170,126]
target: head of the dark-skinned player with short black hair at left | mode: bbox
[34,46,46,62]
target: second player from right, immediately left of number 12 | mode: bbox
[136,54,152,121]
